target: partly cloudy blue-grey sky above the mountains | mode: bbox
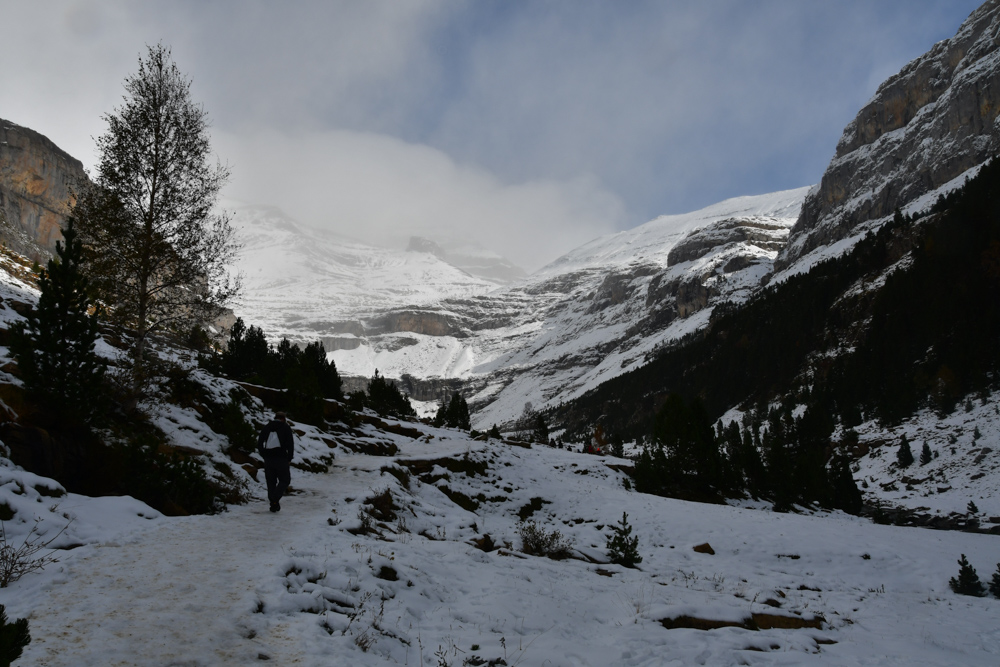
[0,0,979,271]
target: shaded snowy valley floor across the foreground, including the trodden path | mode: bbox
[0,425,1000,667]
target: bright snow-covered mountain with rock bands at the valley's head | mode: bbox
[230,188,808,426]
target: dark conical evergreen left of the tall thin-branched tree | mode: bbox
[11,218,105,422]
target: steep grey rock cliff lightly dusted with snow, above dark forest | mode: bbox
[775,0,1000,270]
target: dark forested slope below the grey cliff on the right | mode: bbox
[554,161,1000,438]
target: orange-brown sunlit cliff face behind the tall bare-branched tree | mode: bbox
[0,119,87,259]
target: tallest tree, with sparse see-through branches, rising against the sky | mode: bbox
[73,45,239,407]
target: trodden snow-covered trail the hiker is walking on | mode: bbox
[19,476,330,667]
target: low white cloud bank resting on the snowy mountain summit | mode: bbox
[216,129,624,270]
